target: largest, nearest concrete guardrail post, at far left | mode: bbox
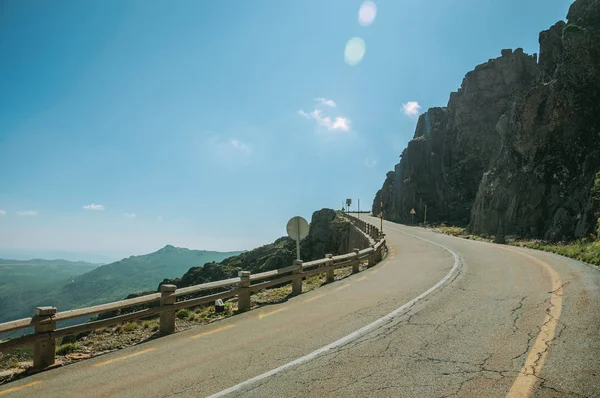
[33,307,56,370]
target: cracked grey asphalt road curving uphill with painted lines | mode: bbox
[0,215,600,398]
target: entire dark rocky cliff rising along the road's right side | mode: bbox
[373,0,600,240]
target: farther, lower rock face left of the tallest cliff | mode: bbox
[373,49,538,224]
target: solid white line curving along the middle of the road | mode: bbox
[207,228,461,398]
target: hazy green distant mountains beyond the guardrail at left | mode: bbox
[0,245,241,322]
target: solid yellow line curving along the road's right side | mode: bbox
[504,248,563,398]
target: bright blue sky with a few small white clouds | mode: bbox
[0,0,571,259]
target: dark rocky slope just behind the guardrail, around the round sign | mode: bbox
[162,209,369,287]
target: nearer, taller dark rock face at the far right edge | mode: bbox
[470,0,600,240]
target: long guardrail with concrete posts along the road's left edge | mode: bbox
[0,214,386,370]
